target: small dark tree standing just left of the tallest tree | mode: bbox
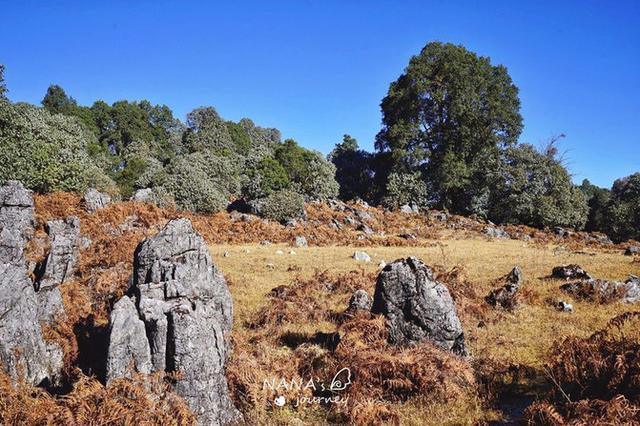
[328,135,373,201]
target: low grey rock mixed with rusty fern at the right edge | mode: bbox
[560,275,640,303]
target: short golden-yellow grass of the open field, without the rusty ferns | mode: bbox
[215,238,640,424]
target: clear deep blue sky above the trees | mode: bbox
[0,0,640,187]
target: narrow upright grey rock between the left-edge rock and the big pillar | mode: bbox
[35,216,81,322]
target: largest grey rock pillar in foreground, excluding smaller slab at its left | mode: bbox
[108,219,242,425]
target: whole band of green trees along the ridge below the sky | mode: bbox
[0,42,640,240]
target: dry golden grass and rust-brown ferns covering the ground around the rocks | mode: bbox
[0,194,640,425]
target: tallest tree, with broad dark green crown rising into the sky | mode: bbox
[376,42,522,213]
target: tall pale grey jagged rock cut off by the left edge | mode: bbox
[0,181,63,385]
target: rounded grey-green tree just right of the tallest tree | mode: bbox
[488,144,588,229]
